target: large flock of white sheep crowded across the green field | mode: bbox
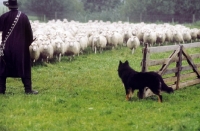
[1,19,200,62]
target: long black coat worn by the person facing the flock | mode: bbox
[0,10,33,78]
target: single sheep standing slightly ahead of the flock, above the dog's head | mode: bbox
[127,36,140,54]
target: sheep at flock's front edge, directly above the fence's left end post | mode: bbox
[143,30,157,46]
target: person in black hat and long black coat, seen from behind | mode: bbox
[0,0,38,94]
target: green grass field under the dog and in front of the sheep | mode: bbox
[0,47,200,131]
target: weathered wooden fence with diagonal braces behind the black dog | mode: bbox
[141,42,200,97]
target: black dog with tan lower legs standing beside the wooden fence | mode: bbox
[118,61,173,102]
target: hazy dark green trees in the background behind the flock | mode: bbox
[3,0,200,22]
